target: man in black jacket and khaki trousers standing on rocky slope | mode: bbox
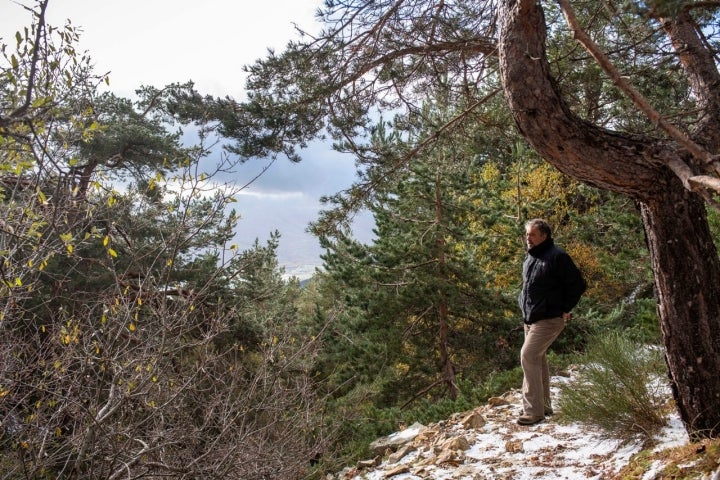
[517,219,587,425]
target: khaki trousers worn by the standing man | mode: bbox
[520,317,565,417]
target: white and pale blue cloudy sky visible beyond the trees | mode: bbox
[0,0,369,277]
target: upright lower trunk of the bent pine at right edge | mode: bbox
[641,179,720,437]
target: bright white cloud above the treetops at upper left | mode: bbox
[0,0,322,97]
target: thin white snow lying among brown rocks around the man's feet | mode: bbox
[336,377,689,480]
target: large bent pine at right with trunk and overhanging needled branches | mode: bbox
[180,0,720,435]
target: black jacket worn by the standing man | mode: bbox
[518,238,587,324]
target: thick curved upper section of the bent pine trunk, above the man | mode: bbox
[498,0,666,201]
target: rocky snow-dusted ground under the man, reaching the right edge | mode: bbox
[328,377,720,480]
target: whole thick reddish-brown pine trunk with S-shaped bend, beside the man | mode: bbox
[499,0,720,437]
